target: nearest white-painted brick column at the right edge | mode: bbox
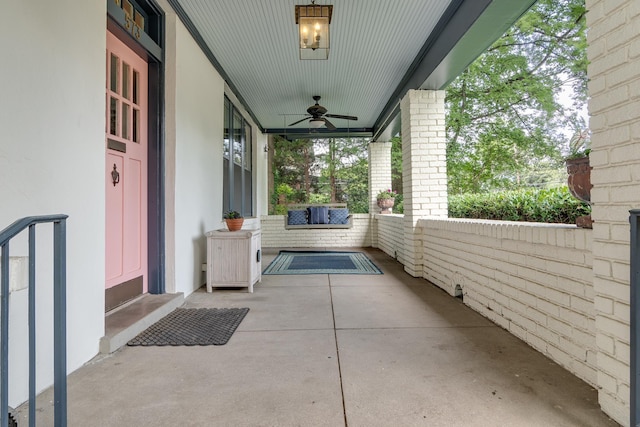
[586,0,640,425]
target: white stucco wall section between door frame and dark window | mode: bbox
[175,23,224,294]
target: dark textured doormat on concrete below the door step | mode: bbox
[127,308,249,346]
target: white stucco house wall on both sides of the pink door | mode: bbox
[0,0,267,406]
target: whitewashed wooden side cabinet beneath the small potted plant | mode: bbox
[207,229,262,292]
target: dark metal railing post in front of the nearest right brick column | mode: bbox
[629,209,640,426]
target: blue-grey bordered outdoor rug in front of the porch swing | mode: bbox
[262,251,382,274]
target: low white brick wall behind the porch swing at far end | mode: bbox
[260,214,371,248]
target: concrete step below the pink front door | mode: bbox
[100,292,184,354]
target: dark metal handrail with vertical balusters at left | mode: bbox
[0,215,68,427]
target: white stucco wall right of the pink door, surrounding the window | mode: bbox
[158,0,268,295]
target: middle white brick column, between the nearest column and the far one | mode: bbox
[400,90,447,277]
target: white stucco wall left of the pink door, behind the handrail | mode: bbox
[0,0,106,406]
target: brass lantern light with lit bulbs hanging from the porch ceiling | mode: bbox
[296,0,333,59]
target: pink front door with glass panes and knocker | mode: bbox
[105,32,148,310]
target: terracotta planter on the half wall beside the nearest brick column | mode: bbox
[565,130,593,228]
